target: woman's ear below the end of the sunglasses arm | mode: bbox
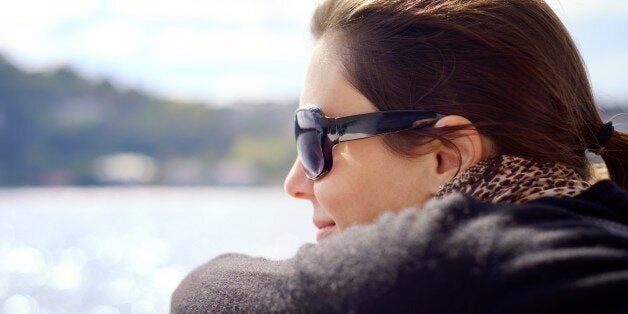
[432,115,484,184]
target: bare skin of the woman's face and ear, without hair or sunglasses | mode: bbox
[285,34,487,239]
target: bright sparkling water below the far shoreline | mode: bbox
[0,187,315,314]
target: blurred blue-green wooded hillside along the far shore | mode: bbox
[0,56,628,186]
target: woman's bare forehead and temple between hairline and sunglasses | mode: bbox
[299,36,377,116]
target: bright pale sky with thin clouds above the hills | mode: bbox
[0,0,628,104]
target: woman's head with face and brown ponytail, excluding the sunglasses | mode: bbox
[286,0,628,240]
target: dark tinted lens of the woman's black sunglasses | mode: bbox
[294,110,325,179]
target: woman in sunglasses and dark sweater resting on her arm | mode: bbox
[172,0,628,313]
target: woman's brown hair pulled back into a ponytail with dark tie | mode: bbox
[311,0,628,190]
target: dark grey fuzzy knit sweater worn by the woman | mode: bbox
[171,180,628,313]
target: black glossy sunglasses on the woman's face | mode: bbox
[294,104,445,180]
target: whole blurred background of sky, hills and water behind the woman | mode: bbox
[0,0,628,313]
